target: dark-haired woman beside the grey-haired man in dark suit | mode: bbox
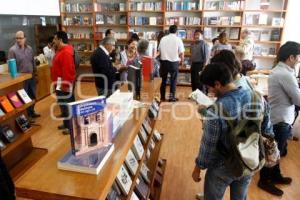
[120,39,138,81]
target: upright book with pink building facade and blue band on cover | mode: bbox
[68,96,113,155]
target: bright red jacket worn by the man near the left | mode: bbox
[51,45,76,92]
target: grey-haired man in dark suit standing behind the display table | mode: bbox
[91,37,124,97]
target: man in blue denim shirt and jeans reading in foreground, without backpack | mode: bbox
[192,63,272,200]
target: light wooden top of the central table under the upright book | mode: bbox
[16,79,161,200]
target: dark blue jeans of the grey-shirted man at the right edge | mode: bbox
[273,122,292,156]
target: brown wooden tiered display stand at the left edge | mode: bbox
[0,74,47,179]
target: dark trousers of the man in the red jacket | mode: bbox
[56,90,75,129]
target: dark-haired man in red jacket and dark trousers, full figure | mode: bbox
[51,31,76,135]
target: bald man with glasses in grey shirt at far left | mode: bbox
[8,31,40,118]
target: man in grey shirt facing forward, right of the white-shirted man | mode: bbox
[191,30,209,91]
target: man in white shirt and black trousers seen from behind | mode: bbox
[158,25,184,102]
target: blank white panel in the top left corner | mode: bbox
[0,0,60,16]
